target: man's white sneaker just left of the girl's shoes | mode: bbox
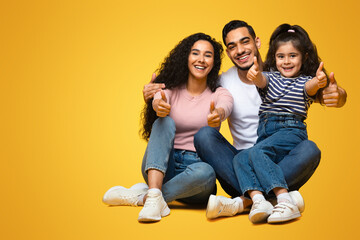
[206,195,243,219]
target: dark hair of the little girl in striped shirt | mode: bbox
[264,23,326,100]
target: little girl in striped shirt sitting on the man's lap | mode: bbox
[233,24,327,223]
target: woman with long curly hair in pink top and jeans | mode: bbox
[103,33,233,222]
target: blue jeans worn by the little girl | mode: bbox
[233,113,308,194]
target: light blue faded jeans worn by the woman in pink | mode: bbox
[142,117,216,203]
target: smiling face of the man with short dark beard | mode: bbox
[225,27,261,71]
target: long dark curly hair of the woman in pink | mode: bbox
[141,33,223,140]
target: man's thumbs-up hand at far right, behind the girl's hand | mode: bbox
[322,72,347,107]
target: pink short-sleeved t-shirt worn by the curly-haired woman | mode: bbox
[154,86,233,152]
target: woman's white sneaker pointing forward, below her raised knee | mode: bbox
[138,190,170,222]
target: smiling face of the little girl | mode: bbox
[275,41,302,78]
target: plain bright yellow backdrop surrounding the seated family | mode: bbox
[0,0,360,239]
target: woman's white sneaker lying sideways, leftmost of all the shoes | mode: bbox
[103,183,149,206]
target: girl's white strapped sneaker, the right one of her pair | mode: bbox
[268,202,301,223]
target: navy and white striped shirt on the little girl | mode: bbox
[258,71,314,118]
